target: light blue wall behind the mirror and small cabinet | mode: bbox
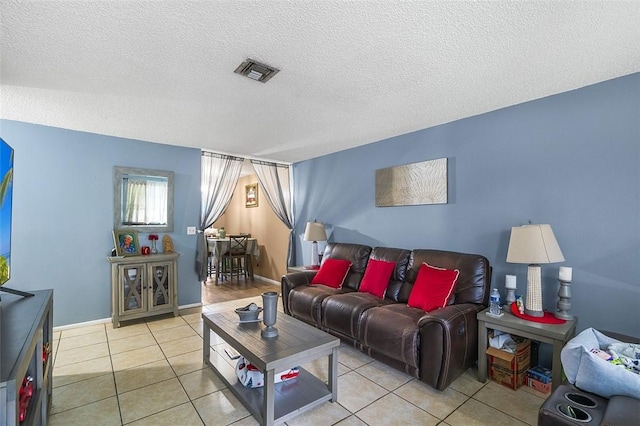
[0,120,201,326]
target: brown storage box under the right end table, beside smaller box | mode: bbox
[487,336,531,389]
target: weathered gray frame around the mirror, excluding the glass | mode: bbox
[113,166,174,233]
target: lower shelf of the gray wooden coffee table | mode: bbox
[208,351,332,424]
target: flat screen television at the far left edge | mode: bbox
[0,138,33,296]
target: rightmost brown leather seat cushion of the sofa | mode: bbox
[358,303,425,369]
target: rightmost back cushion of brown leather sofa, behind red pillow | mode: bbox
[400,249,491,305]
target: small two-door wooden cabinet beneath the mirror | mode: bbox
[108,253,179,328]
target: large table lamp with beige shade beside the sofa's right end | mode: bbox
[507,225,564,317]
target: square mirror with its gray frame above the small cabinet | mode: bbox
[113,166,173,232]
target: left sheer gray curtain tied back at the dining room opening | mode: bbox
[196,152,244,281]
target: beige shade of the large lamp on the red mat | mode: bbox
[507,225,564,265]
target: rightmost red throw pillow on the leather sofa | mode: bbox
[407,263,460,312]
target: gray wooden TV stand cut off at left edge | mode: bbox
[0,290,53,426]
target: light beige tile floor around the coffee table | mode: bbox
[49,297,546,426]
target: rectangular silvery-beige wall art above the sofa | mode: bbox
[376,158,447,207]
